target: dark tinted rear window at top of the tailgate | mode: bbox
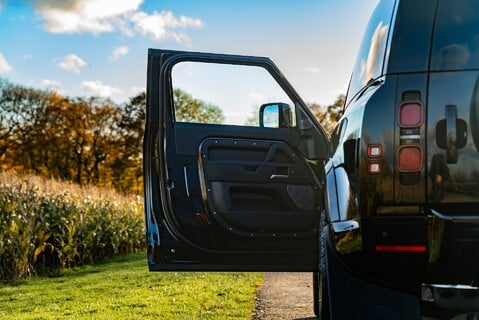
[431,0,479,71]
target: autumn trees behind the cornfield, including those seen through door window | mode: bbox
[0,79,344,194]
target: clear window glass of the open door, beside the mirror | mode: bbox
[171,62,294,127]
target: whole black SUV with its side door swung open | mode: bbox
[144,0,479,320]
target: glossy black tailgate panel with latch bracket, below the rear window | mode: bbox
[427,70,479,204]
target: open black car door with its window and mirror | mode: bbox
[143,49,329,271]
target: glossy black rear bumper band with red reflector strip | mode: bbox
[330,208,479,292]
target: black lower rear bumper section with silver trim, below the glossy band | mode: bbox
[326,225,479,320]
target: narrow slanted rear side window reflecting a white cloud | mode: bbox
[346,1,394,105]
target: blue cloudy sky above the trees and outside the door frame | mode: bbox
[0,0,378,104]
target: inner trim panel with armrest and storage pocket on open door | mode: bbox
[200,138,320,236]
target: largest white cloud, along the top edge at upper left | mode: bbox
[29,0,203,43]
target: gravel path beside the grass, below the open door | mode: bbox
[252,272,317,320]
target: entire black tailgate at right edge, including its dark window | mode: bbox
[427,0,479,205]
